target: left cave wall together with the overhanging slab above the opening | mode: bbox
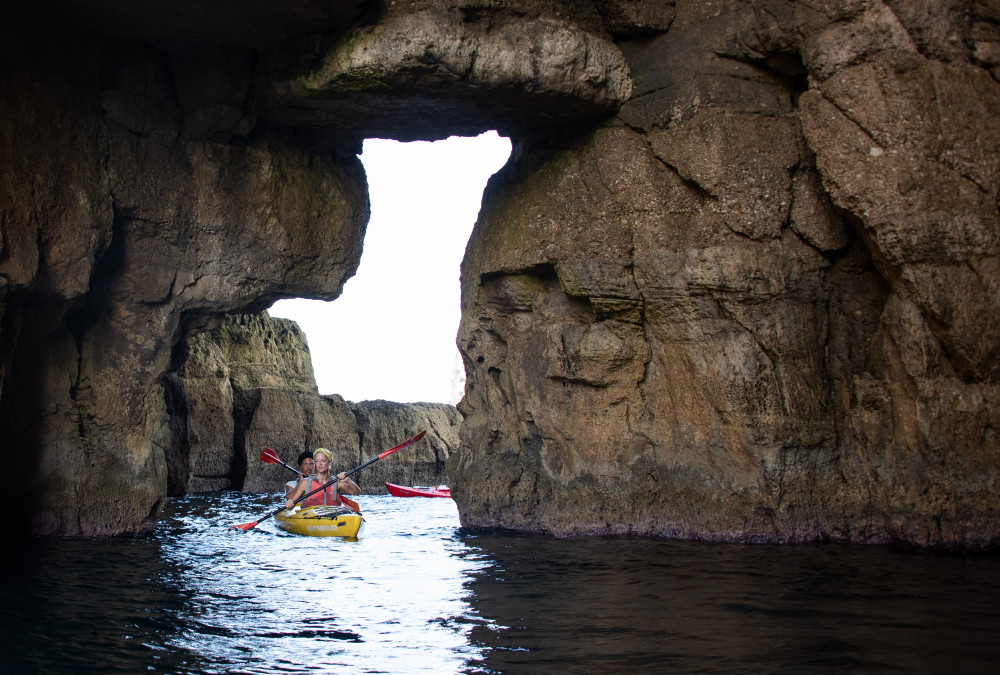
[0,0,632,535]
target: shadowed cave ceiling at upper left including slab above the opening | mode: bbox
[38,0,632,152]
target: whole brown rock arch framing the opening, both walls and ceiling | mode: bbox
[0,0,1000,548]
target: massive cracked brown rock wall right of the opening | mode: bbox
[450,1,1000,548]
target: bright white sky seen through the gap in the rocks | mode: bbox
[269,131,511,404]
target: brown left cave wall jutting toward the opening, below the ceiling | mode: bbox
[0,6,368,535]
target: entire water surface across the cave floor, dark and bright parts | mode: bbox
[0,493,1000,673]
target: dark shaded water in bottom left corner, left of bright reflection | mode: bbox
[0,539,200,673]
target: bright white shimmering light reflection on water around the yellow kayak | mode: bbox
[150,497,479,673]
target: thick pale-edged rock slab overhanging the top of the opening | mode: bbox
[258,0,632,144]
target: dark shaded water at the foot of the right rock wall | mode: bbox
[465,533,1000,673]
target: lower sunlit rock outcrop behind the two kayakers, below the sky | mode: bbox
[173,312,460,495]
